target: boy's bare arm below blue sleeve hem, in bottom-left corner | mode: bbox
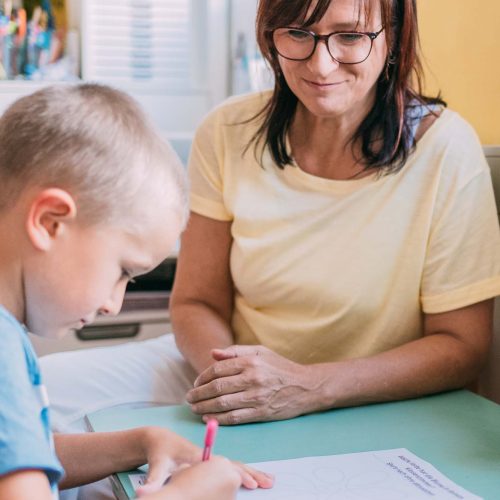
[0,470,53,500]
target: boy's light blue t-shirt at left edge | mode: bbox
[0,306,64,491]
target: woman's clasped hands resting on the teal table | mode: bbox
[186,345,318,425]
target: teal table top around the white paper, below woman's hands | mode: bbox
[87,391,500,500]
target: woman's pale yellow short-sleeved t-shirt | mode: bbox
[189,93,500,363]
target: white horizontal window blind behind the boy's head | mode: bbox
[82,0,197,94]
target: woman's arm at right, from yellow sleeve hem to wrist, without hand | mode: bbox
[308,300,493,407]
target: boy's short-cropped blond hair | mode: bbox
[0,84,188,229]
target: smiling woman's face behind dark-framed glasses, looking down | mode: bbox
[278,0,387,120]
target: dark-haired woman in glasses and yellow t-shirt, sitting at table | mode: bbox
[171,0,500,424]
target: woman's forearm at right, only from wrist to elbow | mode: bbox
[310,334,488,411]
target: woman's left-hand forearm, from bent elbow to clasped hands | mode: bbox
[170,301,233,373]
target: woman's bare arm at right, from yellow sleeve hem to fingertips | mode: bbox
[186,300,493,425]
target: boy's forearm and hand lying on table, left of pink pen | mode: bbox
[54,427,197,489]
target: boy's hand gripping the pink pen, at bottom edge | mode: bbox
[137,457,274,500]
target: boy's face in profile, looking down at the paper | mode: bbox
[24,203,181,338]
